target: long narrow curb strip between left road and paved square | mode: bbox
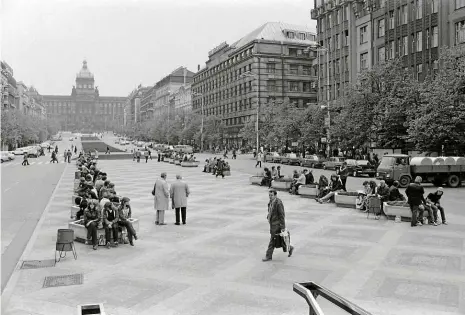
[1,163,69,313]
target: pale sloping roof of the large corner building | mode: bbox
[231,22,316,49]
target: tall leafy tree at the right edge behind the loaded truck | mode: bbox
[408,48,465,154]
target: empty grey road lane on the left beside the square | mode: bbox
[1,162,67,292]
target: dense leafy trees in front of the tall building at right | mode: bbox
[330,45,465,155]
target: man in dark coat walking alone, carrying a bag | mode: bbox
[262,189,294,261]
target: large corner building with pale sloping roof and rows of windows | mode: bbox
[192,22,317,146]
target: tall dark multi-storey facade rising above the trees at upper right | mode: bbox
[311,0,465,105]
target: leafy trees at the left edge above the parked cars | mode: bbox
[1,110,59,150]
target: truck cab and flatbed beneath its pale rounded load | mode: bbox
[376,154,465,188]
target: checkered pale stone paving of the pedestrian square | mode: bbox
[5,160,465,315]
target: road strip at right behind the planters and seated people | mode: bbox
[200,154,465,217]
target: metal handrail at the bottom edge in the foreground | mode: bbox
[293,282,372,315]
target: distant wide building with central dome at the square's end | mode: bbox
[42,60,127,132]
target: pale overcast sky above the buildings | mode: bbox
[0,0,316,96]
